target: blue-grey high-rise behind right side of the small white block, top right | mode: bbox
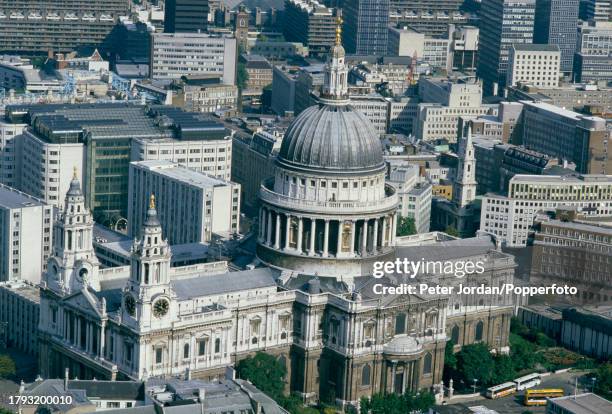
[533,0,580,75]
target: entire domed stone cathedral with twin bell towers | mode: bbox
[40,29,515,406]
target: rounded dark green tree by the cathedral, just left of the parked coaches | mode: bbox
[456,343,495,386]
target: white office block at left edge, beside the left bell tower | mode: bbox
[0,184,53,284]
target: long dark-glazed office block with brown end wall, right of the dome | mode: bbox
[521,101,612,174]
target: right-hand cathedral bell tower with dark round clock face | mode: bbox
[123,195,174,327]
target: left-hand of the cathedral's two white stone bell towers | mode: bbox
[45,168,100,294]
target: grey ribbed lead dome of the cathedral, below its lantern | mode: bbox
[278,105,384,172]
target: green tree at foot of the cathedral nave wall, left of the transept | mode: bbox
[236,352,287,400]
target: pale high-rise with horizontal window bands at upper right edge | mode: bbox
[574,21,612,85]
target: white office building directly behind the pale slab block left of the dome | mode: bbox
[131,135,232,180]
